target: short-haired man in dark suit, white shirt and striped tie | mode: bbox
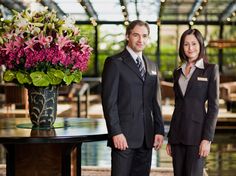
[102,20,164,176]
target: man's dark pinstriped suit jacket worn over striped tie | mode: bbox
[102,49,164,148]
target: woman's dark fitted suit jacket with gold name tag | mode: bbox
[168,63,219,145]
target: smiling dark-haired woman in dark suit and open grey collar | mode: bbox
[166,29,219,176]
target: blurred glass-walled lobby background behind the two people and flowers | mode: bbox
[0,0,236,176]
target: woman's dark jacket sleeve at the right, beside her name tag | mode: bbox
[203,65,219,141]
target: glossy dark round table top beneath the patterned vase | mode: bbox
[0,117,107,144]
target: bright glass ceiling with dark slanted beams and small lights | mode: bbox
[0,0,236,25]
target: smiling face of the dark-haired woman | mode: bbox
[184,34,200,62]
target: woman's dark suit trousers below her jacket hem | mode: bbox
[171,144,205,176]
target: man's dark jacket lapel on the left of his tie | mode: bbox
[121,50,146,80]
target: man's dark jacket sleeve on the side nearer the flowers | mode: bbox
[102,57,122,137]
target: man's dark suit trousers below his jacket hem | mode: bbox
[111,145,152,176]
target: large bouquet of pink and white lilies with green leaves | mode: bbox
[0,8,92,86]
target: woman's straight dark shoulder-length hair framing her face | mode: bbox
[179,29,208,62]
